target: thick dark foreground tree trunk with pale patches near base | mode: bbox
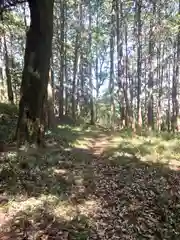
[16,0,54,145]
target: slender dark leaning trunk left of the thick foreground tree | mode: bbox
[4,35,14,104]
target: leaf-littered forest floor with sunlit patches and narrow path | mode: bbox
[0,126,180,240]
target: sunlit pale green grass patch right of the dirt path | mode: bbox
[100,131,180,170]
